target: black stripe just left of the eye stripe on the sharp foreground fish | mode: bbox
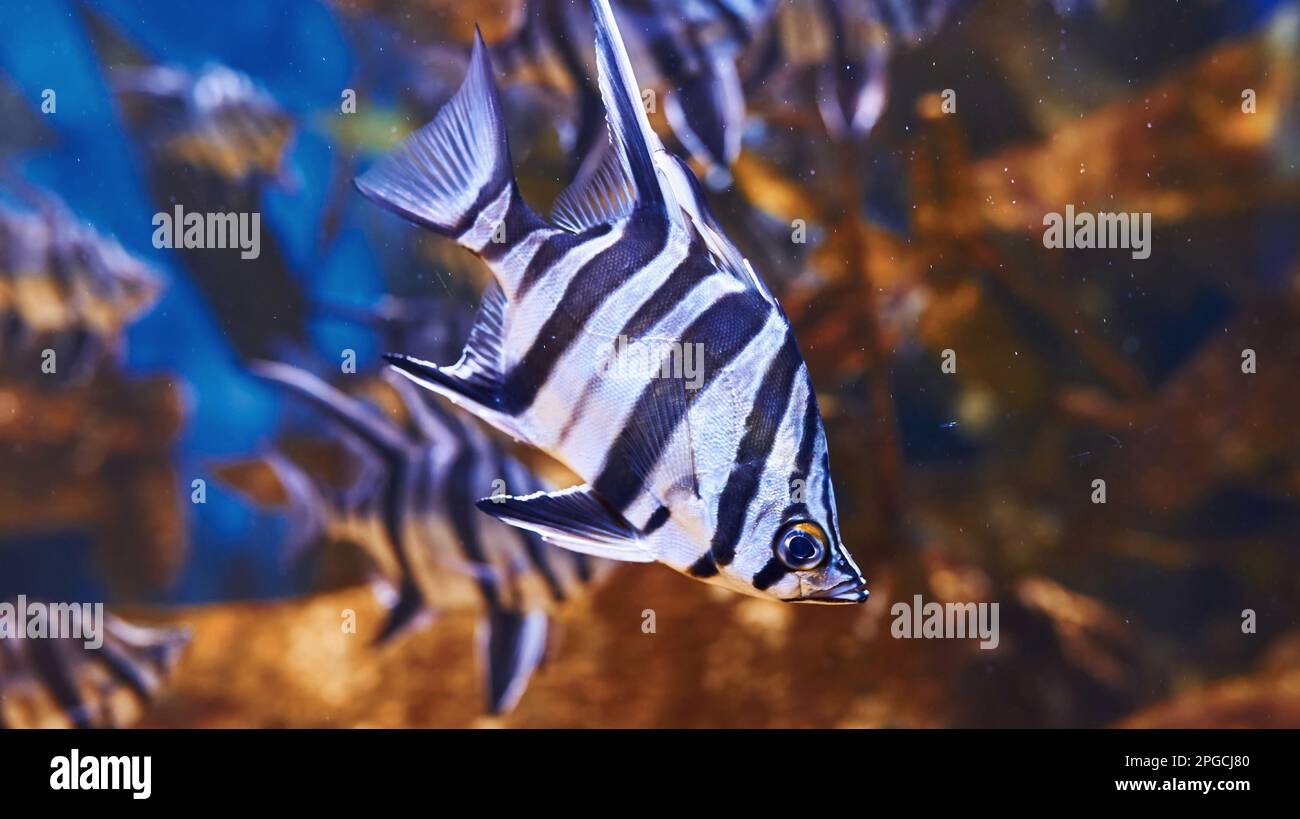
[710,330,802,566]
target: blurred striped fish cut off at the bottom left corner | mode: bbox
[0,615,190,728]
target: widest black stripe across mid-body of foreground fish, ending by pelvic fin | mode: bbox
[592,290,771,512]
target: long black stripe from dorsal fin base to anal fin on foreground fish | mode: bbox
[501,212,668,415]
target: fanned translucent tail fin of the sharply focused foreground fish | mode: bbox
[355,29,543,266]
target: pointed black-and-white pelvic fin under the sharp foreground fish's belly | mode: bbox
[477,484,655,563]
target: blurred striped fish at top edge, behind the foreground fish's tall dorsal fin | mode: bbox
[493,0,775,177]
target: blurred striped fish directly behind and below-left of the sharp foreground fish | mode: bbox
[245,363,611,714]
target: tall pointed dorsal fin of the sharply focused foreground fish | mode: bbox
[592,0,676,218]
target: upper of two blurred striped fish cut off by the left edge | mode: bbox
[0,191,163,382]
